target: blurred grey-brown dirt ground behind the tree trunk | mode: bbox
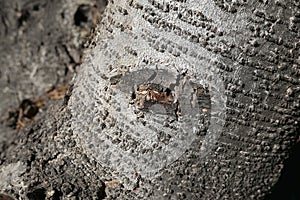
[0,0,106,134]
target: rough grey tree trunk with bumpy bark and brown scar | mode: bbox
[0,0,300,199]
